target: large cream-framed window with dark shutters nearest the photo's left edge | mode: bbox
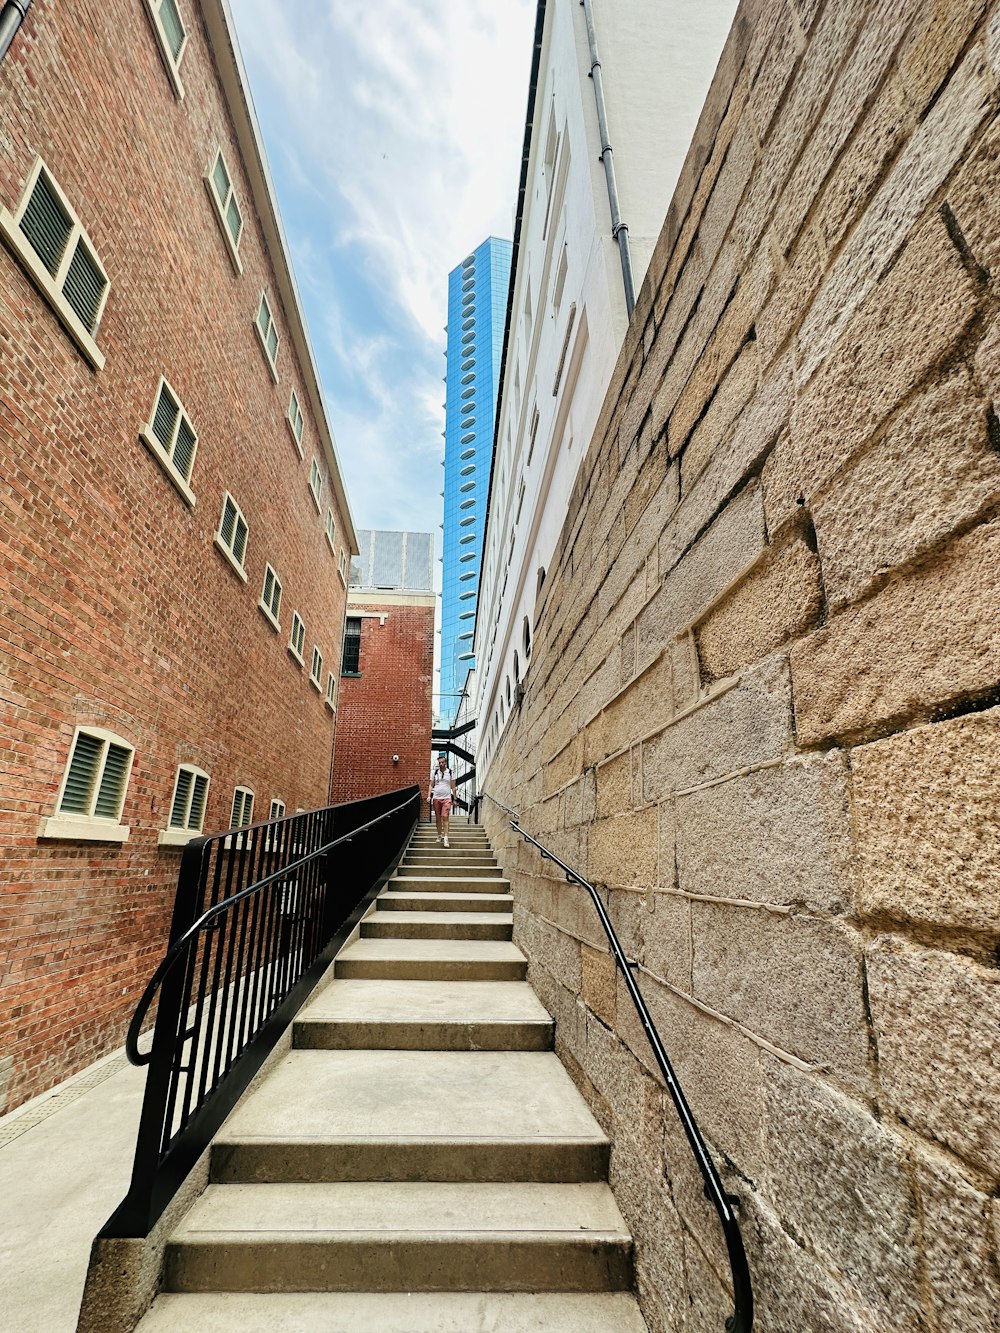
[0,157,111,371]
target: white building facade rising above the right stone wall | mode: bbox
[469,0,736,785]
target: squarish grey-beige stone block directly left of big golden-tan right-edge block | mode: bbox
[677,750,857,912]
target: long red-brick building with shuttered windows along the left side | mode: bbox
[0,0,356,1110]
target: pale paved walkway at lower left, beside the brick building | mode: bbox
[0,1052,145,1333]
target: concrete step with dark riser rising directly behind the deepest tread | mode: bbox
[292,980,553,1050]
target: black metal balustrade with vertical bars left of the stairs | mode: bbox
[100,786,420,1237]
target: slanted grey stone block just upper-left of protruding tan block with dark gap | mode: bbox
[636,483,764,663]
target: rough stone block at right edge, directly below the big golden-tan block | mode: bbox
[868,936,1000,1176]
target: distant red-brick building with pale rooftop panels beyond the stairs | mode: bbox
[331,529,437,802]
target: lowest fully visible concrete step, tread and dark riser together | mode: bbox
[164,1181,632,1292]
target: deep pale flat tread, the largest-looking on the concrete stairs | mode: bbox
[216,1050,607,1144]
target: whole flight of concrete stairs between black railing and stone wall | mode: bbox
[139,825,645,1333]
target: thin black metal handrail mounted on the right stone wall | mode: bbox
[473,792,753,1333]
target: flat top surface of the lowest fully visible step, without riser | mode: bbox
[172,1181,631,1245]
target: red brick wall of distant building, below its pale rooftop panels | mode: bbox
[331,600,435,816]
